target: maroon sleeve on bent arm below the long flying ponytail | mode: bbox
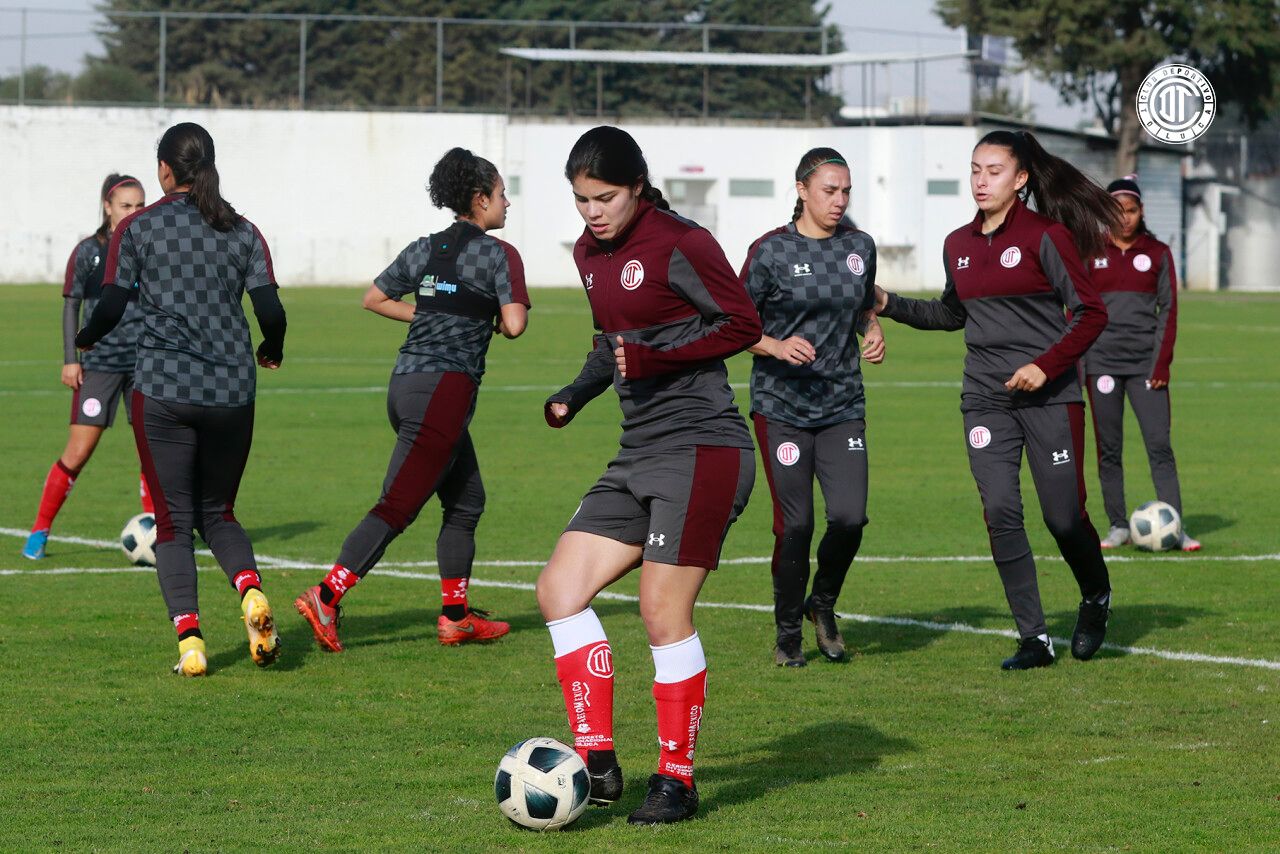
[1032,223,1107,379]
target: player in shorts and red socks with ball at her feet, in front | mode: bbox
[538,127,760,825]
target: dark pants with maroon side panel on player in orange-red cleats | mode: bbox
[338,371,485,579]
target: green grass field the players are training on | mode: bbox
[0,286,1280,851]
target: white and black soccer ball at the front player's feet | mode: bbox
[493,739,591,830]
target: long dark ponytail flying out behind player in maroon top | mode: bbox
[974,131,1120,259]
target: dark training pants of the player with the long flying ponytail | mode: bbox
[964,401,1111,638]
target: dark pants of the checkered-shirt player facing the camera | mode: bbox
[751,412,867,639]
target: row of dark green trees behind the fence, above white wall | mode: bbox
[94,0,841,118]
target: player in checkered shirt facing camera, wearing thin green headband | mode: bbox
[742,149,884,667]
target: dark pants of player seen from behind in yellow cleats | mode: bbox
[132,389,257,618]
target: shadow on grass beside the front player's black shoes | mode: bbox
[698,721,915,813]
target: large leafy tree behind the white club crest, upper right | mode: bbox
[936,0,1280,174]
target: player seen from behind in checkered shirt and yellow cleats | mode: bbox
[76,123,285,676]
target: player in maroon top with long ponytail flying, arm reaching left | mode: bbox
[876,131,1119,670]
